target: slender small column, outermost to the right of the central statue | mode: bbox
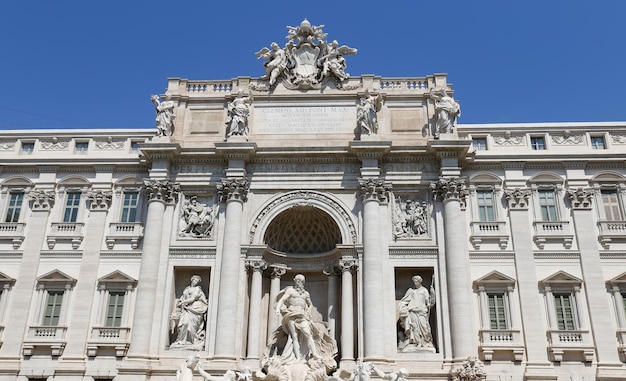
[339,258,357,361]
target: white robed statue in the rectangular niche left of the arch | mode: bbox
[170,275,208,350]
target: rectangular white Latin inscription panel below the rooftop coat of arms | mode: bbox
[250,106,356,135]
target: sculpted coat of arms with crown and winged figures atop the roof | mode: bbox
[254,19,357,90]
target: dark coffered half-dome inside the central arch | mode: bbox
[263,206,341,254]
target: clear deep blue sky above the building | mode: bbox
[0,0,626,129]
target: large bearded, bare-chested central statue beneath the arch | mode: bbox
[263,274,337,381]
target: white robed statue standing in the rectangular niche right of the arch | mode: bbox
[398,275,435,352]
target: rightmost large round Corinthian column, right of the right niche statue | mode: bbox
[431,178,476,360]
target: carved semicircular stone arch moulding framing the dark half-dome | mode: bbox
[248,190,357,245]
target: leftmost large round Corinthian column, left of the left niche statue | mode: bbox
[129,179,180,357]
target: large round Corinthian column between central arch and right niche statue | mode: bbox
[359,178,391,360]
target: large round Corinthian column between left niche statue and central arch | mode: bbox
[215,178,250,359]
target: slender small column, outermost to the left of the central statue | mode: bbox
[246,259,267,360]
